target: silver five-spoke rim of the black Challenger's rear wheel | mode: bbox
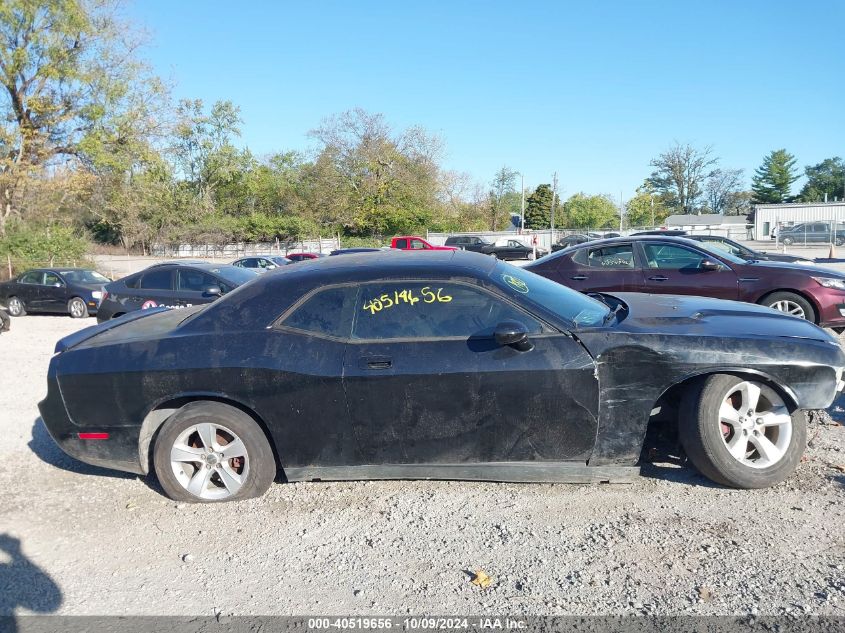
[170,422,249,500]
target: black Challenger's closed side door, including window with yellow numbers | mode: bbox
[343,280,598,464]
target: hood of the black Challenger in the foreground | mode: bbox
[610,292,838,345]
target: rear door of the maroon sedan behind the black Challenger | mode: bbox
[555,242,645,292]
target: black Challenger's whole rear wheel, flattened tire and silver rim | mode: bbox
[153,401,276,503]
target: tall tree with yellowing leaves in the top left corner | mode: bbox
[0,0,166,236]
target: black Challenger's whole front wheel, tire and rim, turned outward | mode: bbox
[678,374,807,489]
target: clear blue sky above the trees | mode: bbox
[127,0,845,199]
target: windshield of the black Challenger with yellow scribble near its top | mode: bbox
[490,262,610,327]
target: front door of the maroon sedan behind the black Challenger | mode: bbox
[638,242,739,300]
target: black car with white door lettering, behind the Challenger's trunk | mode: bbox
[97,262,258,323]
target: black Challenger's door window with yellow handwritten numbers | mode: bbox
[352,281,543,340]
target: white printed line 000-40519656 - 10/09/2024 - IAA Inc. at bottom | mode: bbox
[308,616,527,631]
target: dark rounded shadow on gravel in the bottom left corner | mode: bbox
[0,534,64,631]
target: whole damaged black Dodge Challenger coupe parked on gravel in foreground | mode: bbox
[39,251,845,501]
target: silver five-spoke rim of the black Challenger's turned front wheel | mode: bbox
[719,381,792,468]
